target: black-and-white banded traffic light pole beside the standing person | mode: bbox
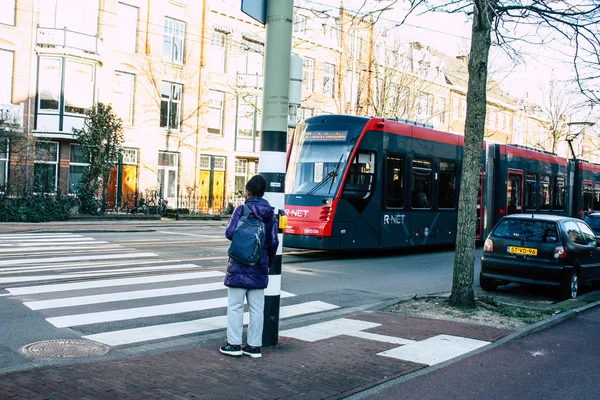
[258,0,294,346]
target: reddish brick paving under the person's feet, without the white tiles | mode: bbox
[0,312,511,400]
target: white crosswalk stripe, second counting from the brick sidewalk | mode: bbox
[46,292,293,328]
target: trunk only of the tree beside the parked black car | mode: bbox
[450,0,495,308]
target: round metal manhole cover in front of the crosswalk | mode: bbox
[21,339,109,358]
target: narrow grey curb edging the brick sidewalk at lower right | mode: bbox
[344,300,600,400]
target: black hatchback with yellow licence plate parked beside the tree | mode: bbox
[479,214,600,300]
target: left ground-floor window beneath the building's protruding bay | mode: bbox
[33,141,58,193]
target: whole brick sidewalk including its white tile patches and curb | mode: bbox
[0,301,599,400]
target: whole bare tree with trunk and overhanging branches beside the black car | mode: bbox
[398,0,600,307]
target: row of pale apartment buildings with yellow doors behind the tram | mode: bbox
[0,0,564,212]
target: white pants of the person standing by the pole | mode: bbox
[227,288,265,347]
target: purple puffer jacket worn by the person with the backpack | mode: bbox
[225,197,279,289]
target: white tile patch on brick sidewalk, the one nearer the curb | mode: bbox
[377,335,490,365]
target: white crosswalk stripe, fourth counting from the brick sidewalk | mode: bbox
[6,271,225,296]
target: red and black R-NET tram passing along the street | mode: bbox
[283,115,600,250]
